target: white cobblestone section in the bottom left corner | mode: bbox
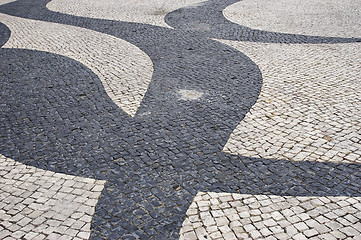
[0,155,105,240]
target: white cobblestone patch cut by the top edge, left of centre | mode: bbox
[46,0,206,27]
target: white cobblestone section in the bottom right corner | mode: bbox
[180,192,361,239]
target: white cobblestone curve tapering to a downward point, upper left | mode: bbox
[0,14,153,116]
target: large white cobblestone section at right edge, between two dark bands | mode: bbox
[222,41,361,163]
